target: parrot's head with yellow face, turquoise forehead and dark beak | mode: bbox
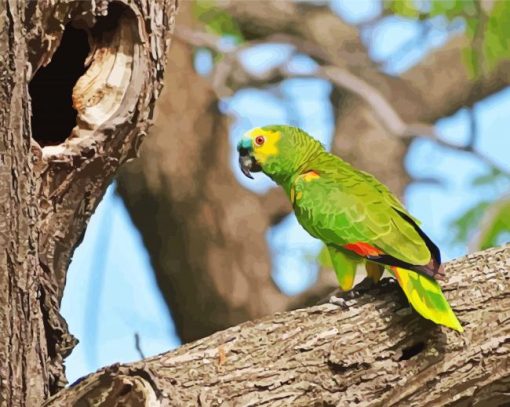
[237,125,324,183]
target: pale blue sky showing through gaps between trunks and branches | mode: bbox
[62,0,510,382]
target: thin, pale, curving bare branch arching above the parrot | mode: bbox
[179,22,510,177]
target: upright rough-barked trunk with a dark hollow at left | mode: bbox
[0,0,177,406]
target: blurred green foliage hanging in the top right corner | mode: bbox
[384,0,510,77]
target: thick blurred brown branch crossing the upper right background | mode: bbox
[219,0,510,123]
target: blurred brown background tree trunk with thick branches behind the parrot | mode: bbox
[118,1,510,342]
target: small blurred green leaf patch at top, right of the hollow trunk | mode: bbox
[193,0,244,43]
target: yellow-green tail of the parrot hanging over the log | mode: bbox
[391,267,464,332]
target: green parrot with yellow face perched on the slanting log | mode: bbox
[237,125,463,332]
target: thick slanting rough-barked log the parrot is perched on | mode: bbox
[42,246,510,407]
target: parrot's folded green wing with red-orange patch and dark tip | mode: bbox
[291,166,442,278]
